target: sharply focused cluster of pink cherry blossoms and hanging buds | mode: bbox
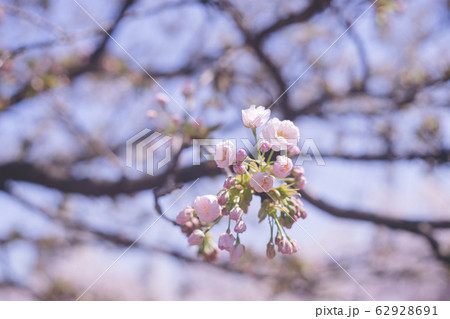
[176,105,306,262]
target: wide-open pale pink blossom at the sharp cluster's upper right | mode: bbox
[261,118,300,151]
